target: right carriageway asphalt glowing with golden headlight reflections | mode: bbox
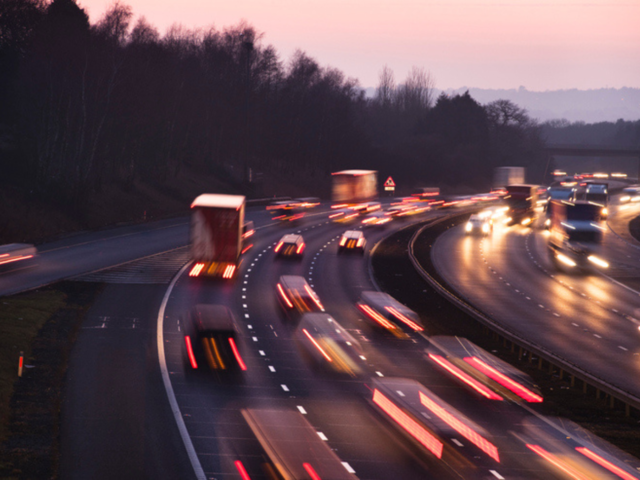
[432,210,640,402]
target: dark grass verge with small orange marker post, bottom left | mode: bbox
[0,282,101,479]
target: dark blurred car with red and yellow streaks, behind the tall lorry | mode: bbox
[183,304,247,372]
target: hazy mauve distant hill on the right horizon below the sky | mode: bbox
[366,87,640,123]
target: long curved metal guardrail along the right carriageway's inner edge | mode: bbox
[409,215,640,415]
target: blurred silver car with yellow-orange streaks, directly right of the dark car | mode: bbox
[295,313,366,377]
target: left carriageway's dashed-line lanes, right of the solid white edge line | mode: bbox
[165,213,568,479]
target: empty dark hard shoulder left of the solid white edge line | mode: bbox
[59,285,191,480]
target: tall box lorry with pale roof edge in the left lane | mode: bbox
[189,193,245,279]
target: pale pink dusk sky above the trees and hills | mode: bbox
[77,0,640,91]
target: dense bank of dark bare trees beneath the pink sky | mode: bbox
[0,0,552,204]
